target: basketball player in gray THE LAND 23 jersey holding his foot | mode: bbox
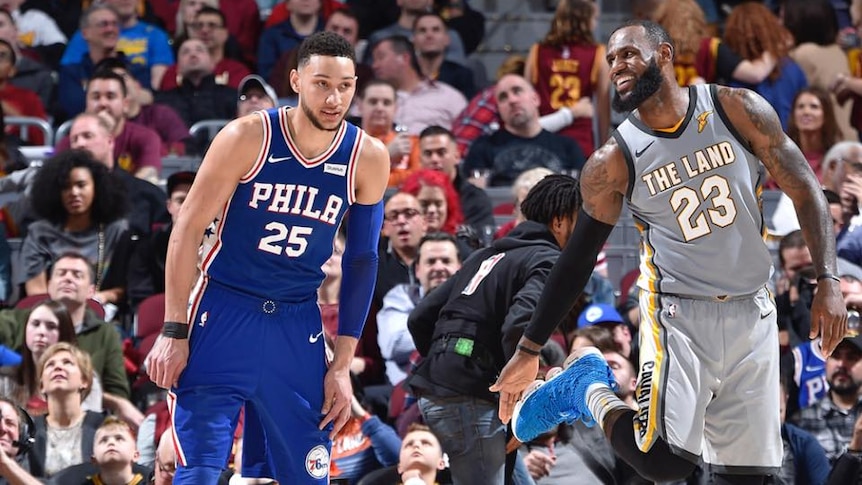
[491,21,847,484]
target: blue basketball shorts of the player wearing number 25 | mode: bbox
[168,280,331,484]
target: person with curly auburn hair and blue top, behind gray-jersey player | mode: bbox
[724,2,808,131]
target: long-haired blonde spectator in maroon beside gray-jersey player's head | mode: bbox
[653,0,775,86]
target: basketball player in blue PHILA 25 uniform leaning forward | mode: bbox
[147,32,389,485]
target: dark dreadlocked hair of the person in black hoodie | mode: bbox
[521,174,581,224]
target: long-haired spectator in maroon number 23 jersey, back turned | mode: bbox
[524,0,611,156]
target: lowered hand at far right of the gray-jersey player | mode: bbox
[810,278,847,357]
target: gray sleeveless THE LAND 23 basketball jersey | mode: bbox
[614,85,772,297]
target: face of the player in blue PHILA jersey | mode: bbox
[290,55,356,131]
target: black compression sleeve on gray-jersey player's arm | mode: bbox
[524,209,614,345]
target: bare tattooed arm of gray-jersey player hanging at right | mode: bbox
[718,87,847,355]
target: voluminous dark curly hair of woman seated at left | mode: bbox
[31,150,129,224]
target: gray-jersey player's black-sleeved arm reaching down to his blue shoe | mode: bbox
[490,139,628,423]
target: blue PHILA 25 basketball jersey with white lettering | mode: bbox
[201,108,364,301]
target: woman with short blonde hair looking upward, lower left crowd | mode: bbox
[28,342,104,478]
